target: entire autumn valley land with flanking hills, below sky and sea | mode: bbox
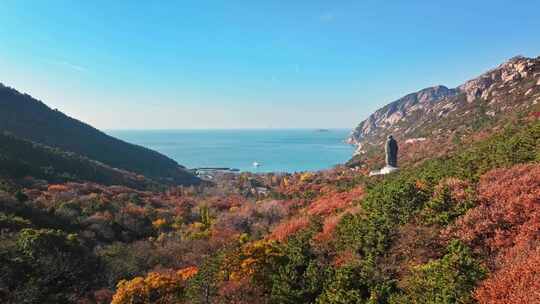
[0,57,540,304]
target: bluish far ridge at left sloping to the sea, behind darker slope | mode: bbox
[0,84,198,184]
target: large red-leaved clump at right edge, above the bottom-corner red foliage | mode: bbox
[446,164,540,257]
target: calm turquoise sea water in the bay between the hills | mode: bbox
[107,130,354,172]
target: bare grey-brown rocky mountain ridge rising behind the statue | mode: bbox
[348,56,540,156]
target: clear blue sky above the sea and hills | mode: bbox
[0,0,540,129]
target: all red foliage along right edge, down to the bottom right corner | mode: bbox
[445,164,540,304]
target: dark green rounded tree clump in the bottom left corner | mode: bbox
[2,228,100,303]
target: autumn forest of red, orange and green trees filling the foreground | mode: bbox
[0,115,540,304]
